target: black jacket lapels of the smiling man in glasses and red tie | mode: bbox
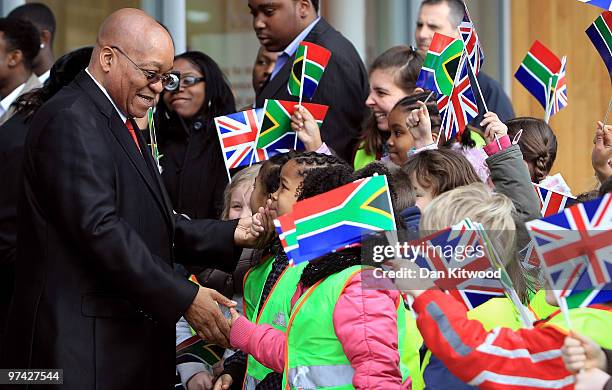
[75,71,173,227]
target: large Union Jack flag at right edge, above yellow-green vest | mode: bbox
[526,194,612,297]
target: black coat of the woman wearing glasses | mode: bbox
[157,114,227,219]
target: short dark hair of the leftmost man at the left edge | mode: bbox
[0,18,40,69]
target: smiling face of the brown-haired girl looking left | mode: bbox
[366,68,406,131]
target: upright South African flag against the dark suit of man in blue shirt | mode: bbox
[287,41,331,102]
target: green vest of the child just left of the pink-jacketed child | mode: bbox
[243,262,308,389]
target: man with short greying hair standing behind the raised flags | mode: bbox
[415,0,514,127]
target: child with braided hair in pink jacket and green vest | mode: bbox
[230,153,410,389]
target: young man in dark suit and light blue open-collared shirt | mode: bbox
[249,0,369,161]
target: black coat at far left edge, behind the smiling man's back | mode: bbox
[0,113,28,340]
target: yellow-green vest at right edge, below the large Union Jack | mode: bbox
[542,305,612,349]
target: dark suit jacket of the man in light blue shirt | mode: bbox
[255,18,369,161]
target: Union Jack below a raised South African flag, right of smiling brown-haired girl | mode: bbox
[438,53,478,141]
